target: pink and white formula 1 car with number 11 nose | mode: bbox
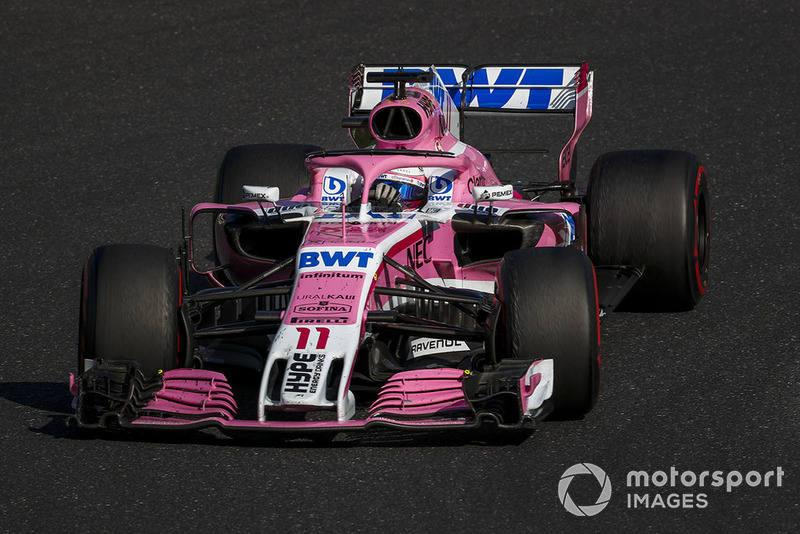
[70,64,710,440]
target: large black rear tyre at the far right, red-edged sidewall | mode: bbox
[587,150,711,311]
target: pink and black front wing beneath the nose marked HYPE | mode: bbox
[70,360,553,434]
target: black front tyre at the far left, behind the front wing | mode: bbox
[78,245,185,376]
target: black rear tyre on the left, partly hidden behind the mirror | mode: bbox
[214,144,322,204]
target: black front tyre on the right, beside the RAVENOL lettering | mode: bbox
[498,248,600,419]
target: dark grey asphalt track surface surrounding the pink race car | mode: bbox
[0,0,800,532]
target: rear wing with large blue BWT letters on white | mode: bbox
[349,63,594,182]
